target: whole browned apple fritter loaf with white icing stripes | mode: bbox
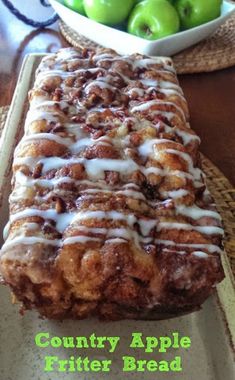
[0,48,224,319]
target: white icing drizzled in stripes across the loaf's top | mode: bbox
[0,51,222,258]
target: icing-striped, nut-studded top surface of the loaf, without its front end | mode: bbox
[2,49,223,259]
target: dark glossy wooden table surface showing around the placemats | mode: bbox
[0,0,235,185]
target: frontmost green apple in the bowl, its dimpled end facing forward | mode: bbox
[127,0,180,40]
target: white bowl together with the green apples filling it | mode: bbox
[50,0,235,56]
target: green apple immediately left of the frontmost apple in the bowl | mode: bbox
[83,0,135,25]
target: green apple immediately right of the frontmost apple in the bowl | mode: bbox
[174,0,222,29]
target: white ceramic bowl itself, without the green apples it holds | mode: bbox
[49,0,235,56]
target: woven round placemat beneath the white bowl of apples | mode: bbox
[59,13,235,74]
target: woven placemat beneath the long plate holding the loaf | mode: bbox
[0,107,235,276]
